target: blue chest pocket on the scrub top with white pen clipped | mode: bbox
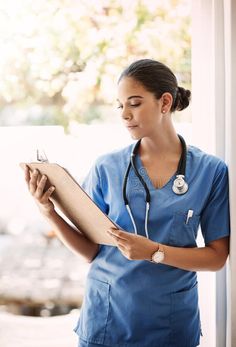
[168,211,200,247]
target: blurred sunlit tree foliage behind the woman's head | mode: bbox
[0,0,191,128]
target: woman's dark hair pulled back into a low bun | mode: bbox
[118,59,191,112]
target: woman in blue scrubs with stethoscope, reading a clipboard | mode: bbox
[25,59,230,347]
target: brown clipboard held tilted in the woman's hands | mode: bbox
[20,162,118,246]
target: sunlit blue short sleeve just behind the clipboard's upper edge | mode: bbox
[81,163,108,214]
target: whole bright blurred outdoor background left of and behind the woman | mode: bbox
[0,0,206,347]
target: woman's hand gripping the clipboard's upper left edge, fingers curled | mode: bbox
[25,166,55,216]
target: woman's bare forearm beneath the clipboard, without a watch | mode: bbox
[45,211,98,262]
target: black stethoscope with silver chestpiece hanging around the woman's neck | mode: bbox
[123,134,188,238]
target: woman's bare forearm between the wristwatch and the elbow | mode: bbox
[162,245,227,271]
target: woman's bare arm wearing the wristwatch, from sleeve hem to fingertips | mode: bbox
[107,228,229,271]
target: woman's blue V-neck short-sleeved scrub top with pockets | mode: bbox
[74,144,230,347]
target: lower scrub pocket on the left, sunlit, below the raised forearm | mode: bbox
[74,277,110,344]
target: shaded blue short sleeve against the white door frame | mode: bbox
[201,162,230,244]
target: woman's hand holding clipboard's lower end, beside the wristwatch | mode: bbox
[107,228,158,260]
